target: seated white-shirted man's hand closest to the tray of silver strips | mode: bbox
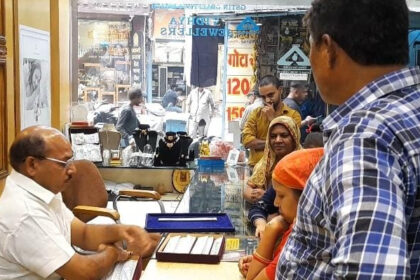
[122,226,160,257]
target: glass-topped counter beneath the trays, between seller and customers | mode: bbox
[141,166,258,280]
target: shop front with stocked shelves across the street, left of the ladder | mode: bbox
[78,20,131,104]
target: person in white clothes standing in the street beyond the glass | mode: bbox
[186,87,215,138]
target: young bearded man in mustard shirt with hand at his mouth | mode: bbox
[242,75,301,166]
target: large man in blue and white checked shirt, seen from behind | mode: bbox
[276,0,420,279]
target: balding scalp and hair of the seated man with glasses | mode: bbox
[9,126,64,171]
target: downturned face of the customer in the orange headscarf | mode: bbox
[272,180,299,224]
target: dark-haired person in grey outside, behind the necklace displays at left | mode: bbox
[116,88,143,148]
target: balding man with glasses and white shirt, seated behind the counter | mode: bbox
[0,126,159,280]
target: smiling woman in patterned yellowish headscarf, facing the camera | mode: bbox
[244,116,302,203]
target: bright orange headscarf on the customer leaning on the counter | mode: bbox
[272,148,324,190]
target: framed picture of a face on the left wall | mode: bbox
[19,25,51,129]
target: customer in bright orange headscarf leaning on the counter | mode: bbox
[239,148,324,280]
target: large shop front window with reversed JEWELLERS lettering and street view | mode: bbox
[72,0,327,142]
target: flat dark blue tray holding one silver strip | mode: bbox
[145,213,235,232]
